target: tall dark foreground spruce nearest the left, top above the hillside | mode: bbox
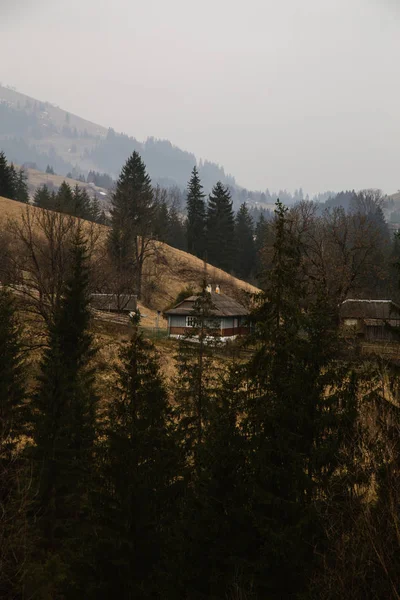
[32,230,97,597]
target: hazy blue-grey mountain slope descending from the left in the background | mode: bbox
[0,86,236,191]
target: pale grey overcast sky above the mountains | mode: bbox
[0,0,400,193]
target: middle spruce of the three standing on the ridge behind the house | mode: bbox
[207,181,235,272]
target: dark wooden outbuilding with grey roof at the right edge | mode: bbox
[339,299,400,342]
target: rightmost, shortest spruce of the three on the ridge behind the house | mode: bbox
[235,203,256,279]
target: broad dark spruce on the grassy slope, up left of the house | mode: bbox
[109,151,155,298]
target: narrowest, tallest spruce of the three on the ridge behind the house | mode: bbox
[186,167,206,258]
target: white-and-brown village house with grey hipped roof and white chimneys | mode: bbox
[165,286,249,341]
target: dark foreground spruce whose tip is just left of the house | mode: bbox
[96,316,181,598]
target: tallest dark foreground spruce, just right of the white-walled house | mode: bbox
[243,201,355,598]
